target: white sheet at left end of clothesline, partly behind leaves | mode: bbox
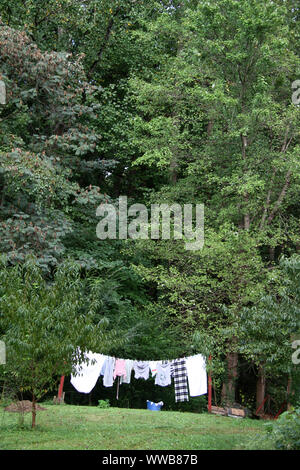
[71,351,106,393]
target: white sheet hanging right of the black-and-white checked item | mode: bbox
[186,354,207,397]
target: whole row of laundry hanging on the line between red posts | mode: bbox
[71,352,207,402]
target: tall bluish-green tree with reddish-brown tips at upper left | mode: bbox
[0,25,100,269]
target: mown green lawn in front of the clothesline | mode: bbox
[0,403,272,450]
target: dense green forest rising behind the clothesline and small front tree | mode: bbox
[0,0,300,410]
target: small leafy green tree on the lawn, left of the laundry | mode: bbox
[0,258,119,427]
